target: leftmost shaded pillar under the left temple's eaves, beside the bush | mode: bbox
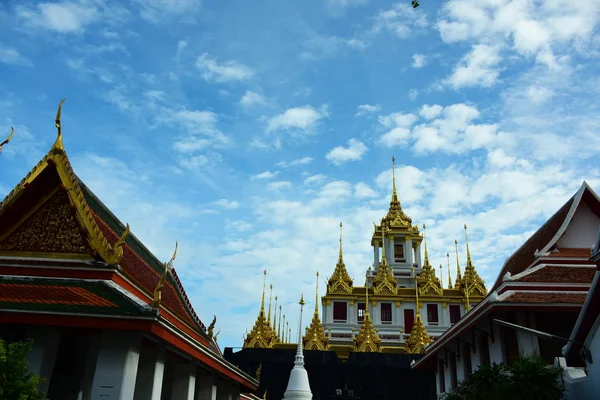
[27,326,61,393]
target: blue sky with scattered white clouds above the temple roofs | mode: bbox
[0,0,600,346]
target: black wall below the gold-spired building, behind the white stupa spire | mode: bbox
[224,347,436,400]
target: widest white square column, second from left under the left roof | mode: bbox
[92,331,142,400]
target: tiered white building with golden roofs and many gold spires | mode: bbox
[240,158,487,359]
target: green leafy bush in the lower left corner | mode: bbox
[0,339,46,400]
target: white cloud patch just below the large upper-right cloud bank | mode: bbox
[446,44,501,89]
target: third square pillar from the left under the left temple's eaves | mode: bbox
[134,343,165,400]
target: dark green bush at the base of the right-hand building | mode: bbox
[442,353,565,400]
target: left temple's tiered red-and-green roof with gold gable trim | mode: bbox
[0,100,255,387]
